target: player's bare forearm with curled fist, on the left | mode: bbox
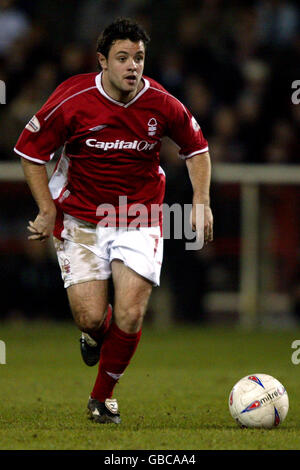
[21,158,56,241]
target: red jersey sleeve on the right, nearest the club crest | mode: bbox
[168,97,208,159]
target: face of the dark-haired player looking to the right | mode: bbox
[98,39,145,101]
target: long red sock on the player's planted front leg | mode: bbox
[91,323,142,402]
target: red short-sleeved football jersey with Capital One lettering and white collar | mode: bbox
[15,73,208,235]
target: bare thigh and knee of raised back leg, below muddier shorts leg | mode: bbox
[67,280,108,332]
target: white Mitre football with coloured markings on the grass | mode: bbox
[228,374,289,429]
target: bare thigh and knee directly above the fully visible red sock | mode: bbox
[111,259,152,332]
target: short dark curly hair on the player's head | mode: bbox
[97,18,150,58]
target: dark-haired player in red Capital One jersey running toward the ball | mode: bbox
[15,19,213,423]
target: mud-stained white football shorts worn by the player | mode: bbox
[54,214,163,288]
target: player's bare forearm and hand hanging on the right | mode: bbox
[186,152,213,243]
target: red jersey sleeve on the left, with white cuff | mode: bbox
[14,86,68,164]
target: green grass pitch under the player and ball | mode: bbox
[0,322,300,450]
